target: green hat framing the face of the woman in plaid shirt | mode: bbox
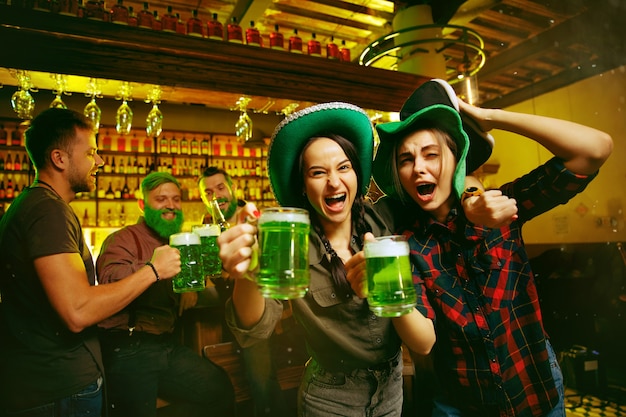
[372,104,469,202]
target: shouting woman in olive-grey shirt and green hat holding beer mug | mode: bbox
[219,103,435,417]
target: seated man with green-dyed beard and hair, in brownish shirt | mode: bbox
[96,172,234,417]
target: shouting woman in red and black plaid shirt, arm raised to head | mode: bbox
[358,79,612,417]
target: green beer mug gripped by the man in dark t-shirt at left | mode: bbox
[170,232,204,293]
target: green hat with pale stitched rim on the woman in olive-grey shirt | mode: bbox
[267,102,374,207]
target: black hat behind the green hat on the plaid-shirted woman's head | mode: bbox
[400,78,495,174]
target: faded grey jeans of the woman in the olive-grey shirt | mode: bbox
[298,356,403,417]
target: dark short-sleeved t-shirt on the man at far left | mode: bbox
[0,187,101,410]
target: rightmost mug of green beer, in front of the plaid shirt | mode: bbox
[364,236,416,317]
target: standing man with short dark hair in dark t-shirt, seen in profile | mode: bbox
[0,108,180,417]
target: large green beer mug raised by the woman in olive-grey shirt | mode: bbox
[257,207,311,300]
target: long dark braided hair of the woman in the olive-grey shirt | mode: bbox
[298,133,372,300]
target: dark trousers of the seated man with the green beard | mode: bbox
[101,332,235,417]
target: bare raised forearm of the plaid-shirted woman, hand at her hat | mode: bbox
[459,100,613,175]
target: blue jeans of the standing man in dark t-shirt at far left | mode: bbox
[6,377,102,417]
